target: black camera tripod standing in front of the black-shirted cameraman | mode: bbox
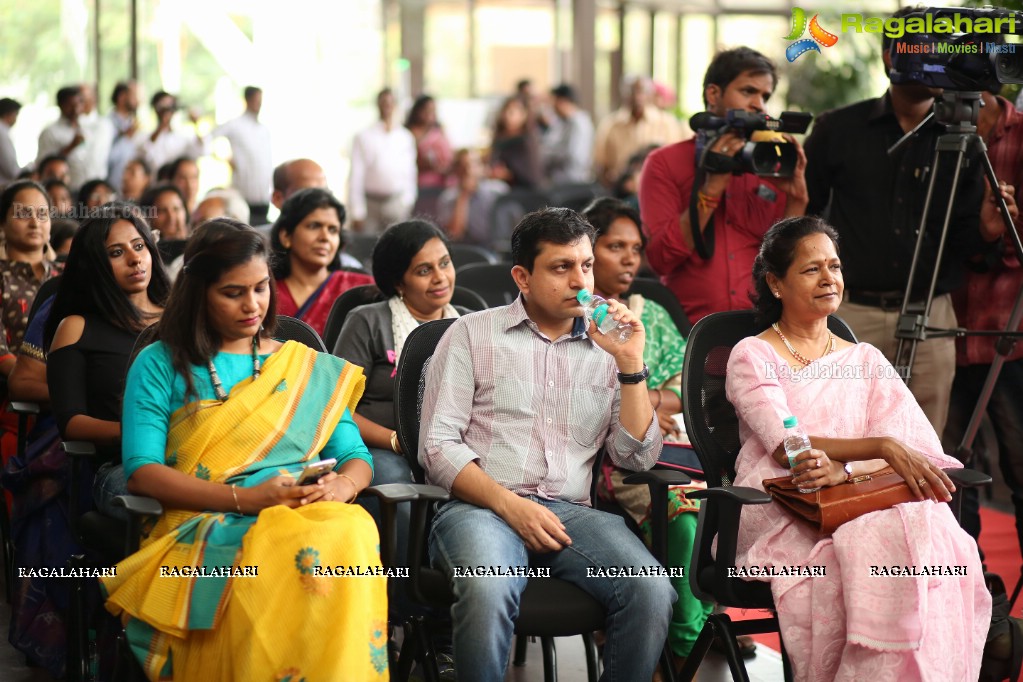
[889,92,1023,604]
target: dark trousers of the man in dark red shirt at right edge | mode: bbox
[943,359,1023,556]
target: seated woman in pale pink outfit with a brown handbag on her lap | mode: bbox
[726,218,991,682]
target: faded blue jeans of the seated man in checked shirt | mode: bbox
[430,497,676,682]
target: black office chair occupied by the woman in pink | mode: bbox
[680,310,990,682]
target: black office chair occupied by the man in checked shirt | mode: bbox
[392,319,605,682]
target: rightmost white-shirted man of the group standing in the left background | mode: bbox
[213,86,273,225]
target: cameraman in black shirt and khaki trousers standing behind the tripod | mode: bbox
[805,7,1005,434]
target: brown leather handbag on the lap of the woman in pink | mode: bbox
[763,466,917,536]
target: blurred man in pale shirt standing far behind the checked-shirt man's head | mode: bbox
[541,84,593,185]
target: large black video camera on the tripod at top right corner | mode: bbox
[885,6,1023,91]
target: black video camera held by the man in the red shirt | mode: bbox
[690,109,813,178]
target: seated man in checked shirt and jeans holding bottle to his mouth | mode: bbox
[419,209,676,682]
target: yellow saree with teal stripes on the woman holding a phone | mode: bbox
[101,343,387,682]
